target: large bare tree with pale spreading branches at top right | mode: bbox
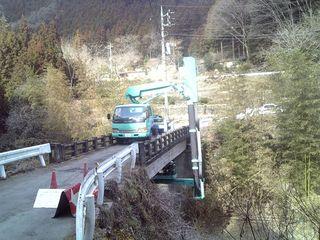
[206,0,312,60]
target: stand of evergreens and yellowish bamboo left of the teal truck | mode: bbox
[0,20,131,150]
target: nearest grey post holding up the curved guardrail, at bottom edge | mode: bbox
[84,194,96,240]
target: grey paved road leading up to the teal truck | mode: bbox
[0,145,126,240]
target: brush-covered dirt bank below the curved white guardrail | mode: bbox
[95,172,200,240]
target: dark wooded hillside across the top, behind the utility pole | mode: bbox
[0,0,214,48]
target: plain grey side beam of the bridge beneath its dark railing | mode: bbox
[145,140,187,179]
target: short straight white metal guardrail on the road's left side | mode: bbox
[0,143,51,178]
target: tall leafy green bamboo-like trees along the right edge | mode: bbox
[270,12,320,194]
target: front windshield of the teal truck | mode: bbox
[113,107,147,122]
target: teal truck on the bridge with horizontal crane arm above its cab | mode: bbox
[108,82,173,142]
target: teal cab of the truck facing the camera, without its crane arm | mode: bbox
[112,104,155,141]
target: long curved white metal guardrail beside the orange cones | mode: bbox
[76,143,138,240]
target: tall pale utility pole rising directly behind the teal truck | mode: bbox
[160,5,173,131]
